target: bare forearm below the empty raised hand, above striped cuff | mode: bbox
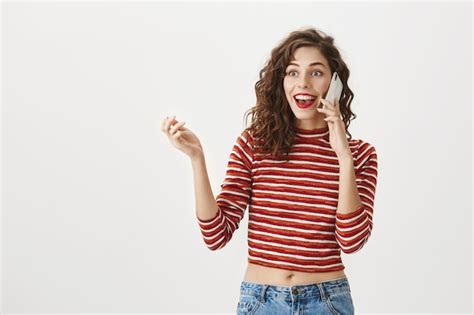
[191,155,218,220]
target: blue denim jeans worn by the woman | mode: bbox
[237,277,354,315]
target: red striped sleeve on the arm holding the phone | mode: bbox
[336,141,378,254]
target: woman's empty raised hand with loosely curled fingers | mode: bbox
[161,115,204,160]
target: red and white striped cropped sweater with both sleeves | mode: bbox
[196,126,377,272]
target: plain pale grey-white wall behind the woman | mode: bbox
[1,2,472,314]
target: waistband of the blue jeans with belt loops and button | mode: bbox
[240,277,351,302]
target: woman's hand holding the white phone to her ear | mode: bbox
[316,99,352,159]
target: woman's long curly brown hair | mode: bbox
[244,27,357,163]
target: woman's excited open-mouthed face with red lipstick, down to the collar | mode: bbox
[283,47,332,129]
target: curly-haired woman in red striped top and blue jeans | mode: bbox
[163,28,377,315]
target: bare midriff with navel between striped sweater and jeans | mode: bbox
[244,262,346,287]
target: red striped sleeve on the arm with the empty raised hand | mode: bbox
[196,129,253,250]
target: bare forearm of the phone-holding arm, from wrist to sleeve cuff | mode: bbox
[337,157,362,214]
